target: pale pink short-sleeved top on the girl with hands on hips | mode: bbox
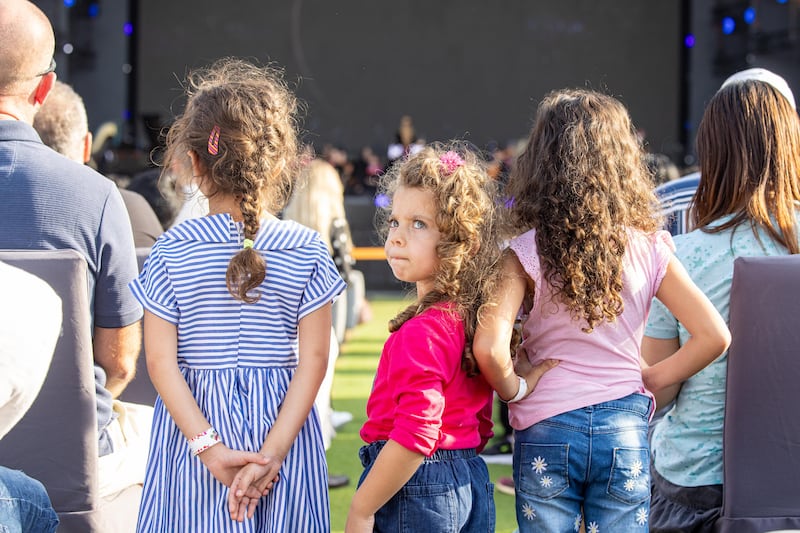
[509,230,675,429]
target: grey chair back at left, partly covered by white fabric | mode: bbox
[0,250,97,514]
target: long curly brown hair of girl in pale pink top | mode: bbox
[506,89,660,333]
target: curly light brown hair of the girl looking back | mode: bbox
[377,143,500,376]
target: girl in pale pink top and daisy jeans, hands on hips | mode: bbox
[473,90,730,533]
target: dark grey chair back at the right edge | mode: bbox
[717,255,800,533]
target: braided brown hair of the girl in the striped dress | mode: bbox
[163,58,299,303]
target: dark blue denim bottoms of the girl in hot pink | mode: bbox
[358,441,495,533]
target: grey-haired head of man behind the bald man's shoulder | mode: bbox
[33,81,89,163]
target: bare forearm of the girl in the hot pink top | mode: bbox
[345,440,425,533]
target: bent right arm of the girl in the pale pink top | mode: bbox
[642,257,731,393]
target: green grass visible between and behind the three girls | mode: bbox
[328,295,516,533]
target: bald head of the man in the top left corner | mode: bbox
[0,0,56,91]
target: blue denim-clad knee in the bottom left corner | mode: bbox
[0,466,58,533]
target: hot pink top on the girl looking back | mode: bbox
[361,304,492,456]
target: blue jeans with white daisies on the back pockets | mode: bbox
[514,394,651,533]
